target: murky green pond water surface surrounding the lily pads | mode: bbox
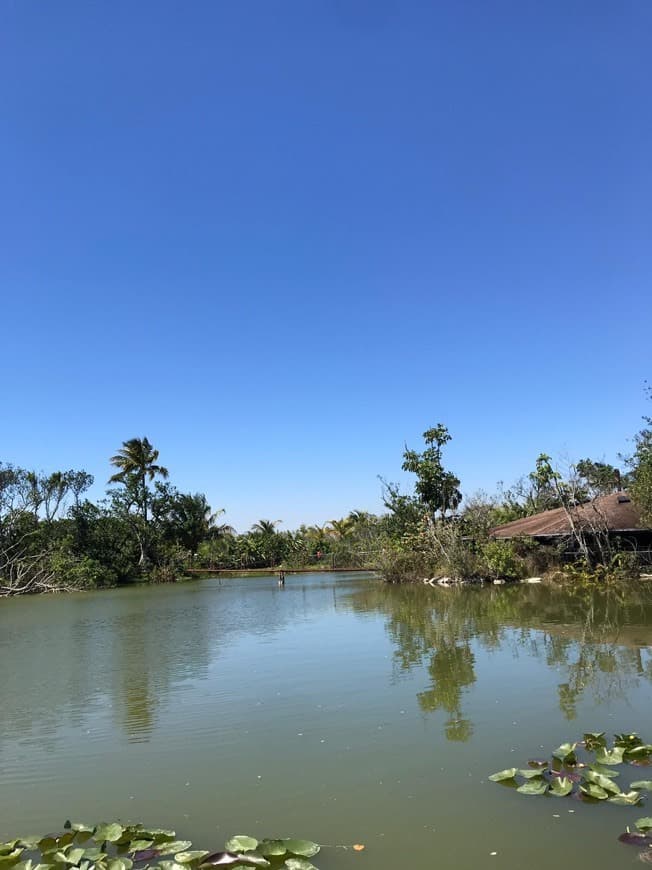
[0,574,652,870]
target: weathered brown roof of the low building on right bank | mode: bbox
[491,492,646,538]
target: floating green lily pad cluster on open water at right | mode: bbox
[489,732,652,806]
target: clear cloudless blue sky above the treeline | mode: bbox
[0,0,652,529]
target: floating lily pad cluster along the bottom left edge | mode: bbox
[0,822,320,870]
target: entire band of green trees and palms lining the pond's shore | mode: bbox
[0,392,652,595]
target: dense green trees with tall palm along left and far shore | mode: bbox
[0,438,386,595]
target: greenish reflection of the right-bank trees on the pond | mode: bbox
[351,585,652,741]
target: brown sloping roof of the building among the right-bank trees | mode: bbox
[491,492,652,550]
